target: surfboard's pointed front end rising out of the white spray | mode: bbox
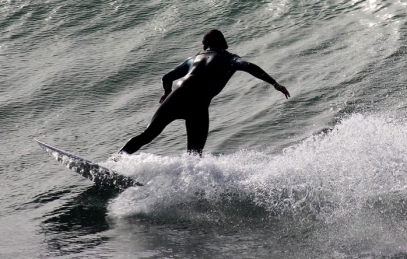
[35,139,143,190]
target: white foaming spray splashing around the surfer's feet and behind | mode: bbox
[106,114,407,230]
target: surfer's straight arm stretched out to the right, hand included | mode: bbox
[233,58,290,99]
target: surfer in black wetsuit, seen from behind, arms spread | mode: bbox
[119,30,290,156]
